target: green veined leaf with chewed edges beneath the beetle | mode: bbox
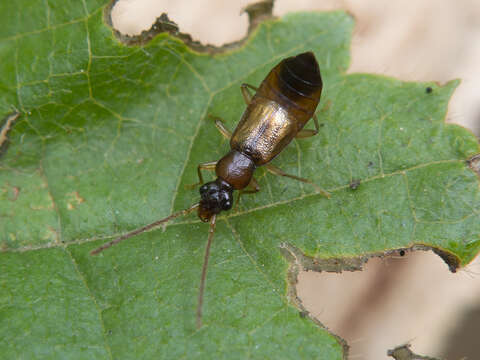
[0,0,480,359]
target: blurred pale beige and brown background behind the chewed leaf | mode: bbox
[109,0,480,360]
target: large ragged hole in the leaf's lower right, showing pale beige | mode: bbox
[297,250,480,359]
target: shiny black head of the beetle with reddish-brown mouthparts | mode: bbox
[198,178,233,222]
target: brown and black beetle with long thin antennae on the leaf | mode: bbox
[90,51,330,327]
